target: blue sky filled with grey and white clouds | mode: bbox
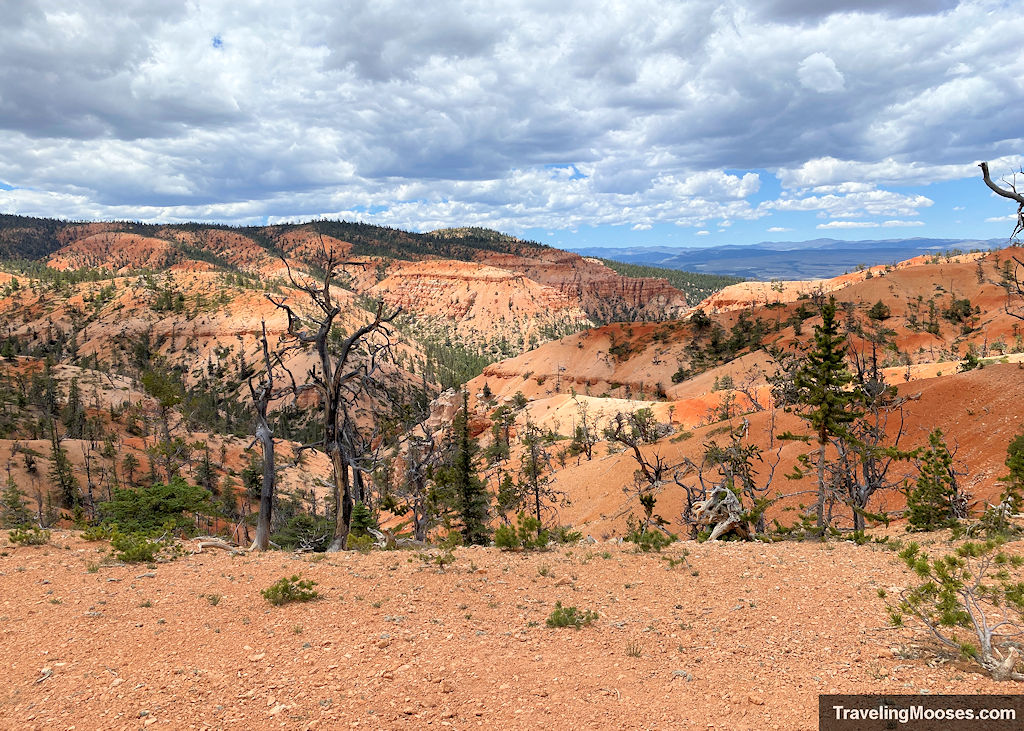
[0,0,1024,248]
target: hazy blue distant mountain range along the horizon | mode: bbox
[572,239,1007,281]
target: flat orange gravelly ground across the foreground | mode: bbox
[0,531,1024,731]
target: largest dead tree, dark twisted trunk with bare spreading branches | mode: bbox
[267,247,401,552]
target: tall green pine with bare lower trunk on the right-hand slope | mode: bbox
[794,297,860,528]
